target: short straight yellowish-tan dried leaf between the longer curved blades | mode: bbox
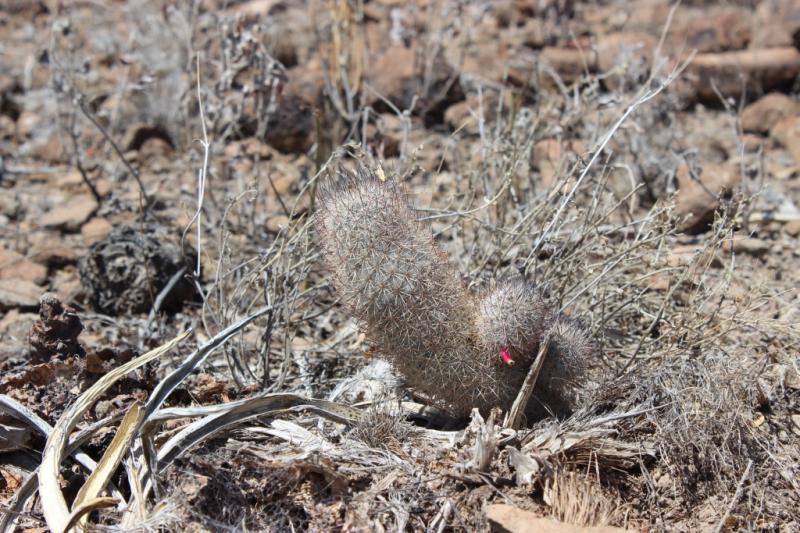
[70,403,144,526]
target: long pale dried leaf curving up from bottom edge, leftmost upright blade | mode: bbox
[39,331,189,533]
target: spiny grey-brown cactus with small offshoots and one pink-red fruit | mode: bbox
[316,166,592,416]
